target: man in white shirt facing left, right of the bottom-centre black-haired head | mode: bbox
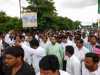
[65,46,81,75]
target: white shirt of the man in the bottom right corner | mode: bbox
[82,63,100,75]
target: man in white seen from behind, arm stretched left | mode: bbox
[21,38,46,73]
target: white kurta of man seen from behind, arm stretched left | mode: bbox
[21,44,46,73]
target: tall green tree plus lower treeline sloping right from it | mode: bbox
[27,0,80,30]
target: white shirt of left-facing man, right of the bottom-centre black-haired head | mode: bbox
[66,55,81,75]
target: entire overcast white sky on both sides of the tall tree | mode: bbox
[0,0,98,24]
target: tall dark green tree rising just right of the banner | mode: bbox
[27,0,57,29]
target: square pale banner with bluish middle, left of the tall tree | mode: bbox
[22,12,37,28]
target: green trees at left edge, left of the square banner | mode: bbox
[0,12,22,32]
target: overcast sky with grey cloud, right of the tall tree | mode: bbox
[54,0,98,24]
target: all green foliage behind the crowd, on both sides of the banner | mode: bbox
[0,0,81,32]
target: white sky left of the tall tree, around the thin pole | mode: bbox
[0,0,28,17]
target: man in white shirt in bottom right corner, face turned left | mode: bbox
[82,53,100,75]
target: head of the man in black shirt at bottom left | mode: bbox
[3,46,24,67]
